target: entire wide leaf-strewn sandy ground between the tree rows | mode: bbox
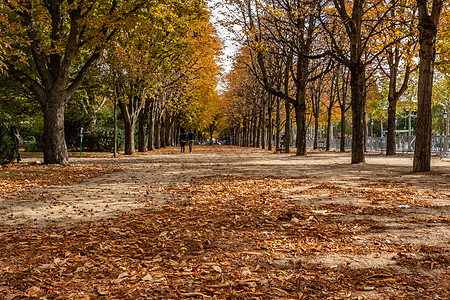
[0,146,450,299]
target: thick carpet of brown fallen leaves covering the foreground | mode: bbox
[0,176,449,300]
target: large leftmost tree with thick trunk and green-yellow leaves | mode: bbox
[0,0,138,165]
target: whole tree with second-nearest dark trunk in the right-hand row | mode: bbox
[321,0,398,163]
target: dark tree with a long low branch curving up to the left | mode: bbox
[246,0,329,155]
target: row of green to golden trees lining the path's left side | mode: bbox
[0,0,221,164]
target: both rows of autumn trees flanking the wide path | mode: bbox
[0,0,450,171]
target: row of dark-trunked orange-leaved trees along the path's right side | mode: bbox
[219,0,449,171]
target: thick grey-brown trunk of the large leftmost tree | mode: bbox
[43,97,69,165]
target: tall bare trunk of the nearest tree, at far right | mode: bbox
[413,0,444,172]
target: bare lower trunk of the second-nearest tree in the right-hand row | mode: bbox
[350,62,366,164]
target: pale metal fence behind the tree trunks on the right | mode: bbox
[306,135,450,156]
